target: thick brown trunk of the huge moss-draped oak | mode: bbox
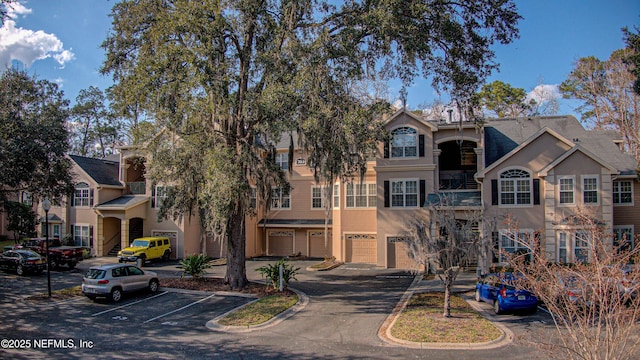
[224,206,248,290]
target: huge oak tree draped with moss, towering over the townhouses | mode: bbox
[102,0,520,288]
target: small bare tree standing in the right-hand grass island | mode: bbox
[403,194,482,317]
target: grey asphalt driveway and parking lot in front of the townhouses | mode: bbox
[0,261,548,359]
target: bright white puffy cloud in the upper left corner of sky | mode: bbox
[0,3,75,67]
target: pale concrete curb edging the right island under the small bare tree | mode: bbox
[378,273,514,350]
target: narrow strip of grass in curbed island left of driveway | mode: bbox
[218,293,298,326]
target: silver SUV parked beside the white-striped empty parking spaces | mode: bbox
[82,264,159,302]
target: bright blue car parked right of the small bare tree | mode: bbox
[476,273,538,314]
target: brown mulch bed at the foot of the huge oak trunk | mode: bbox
[160,278,293,297]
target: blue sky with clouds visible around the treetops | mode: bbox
[0,0,640,114]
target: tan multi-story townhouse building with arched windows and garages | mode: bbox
[22,110,640,268]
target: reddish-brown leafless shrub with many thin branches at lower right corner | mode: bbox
[503,210,640,359]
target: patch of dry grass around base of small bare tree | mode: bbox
[391,293,502,343]
